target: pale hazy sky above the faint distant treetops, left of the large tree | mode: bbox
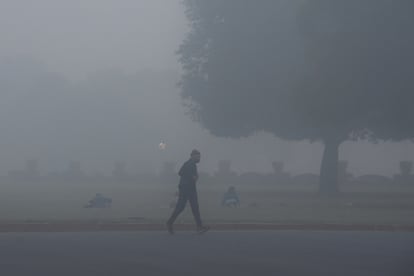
[0,0,186,79]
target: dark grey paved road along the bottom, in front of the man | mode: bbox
[0,231,414,276]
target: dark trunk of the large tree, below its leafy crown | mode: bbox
[319,139,340,195]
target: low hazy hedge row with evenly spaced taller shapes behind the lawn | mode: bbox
[6,160,414,186]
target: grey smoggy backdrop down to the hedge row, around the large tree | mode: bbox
[0,0,414,175]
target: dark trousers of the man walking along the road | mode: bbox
[168,185,203,227]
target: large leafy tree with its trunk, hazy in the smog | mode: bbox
[179,0,414,193]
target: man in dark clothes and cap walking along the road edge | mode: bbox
[167,150,209,234]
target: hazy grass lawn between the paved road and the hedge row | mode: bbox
[0,182,414,225]
